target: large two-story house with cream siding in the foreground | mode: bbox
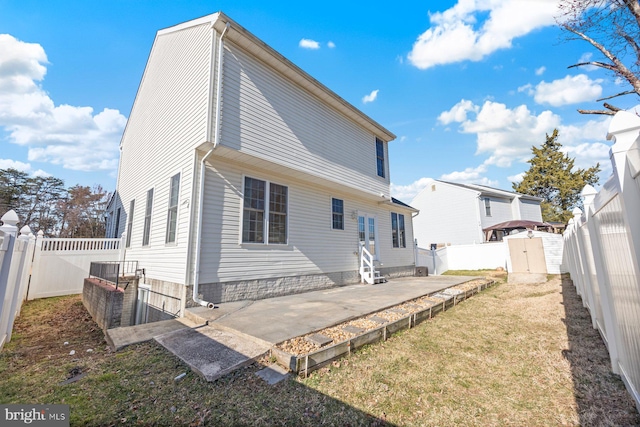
[107,13,417,316]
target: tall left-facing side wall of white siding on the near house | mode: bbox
[118,25,211,283]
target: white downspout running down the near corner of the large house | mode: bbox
[193,22,231,308]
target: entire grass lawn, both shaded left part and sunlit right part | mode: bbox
[0,273,640,426]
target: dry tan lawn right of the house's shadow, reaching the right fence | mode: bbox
[303,277,640,426]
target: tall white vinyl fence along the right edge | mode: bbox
[564,112,640,410]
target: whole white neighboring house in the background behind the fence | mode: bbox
[410,180,542,248]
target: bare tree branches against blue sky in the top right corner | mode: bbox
[557,0,640,115]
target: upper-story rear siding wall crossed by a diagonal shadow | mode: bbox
[221,42,389,195]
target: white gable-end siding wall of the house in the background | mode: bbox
[409,182,484,249]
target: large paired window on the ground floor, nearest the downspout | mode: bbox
[242,177,289,244]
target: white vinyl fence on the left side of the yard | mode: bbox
[0,211,124,350]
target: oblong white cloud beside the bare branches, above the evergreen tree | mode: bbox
[518,74,602,107]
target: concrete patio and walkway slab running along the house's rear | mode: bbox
[107,276,477,381]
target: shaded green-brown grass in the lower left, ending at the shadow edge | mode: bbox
[0,296,385,426]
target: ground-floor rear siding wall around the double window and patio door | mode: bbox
[199,159,414,283]
